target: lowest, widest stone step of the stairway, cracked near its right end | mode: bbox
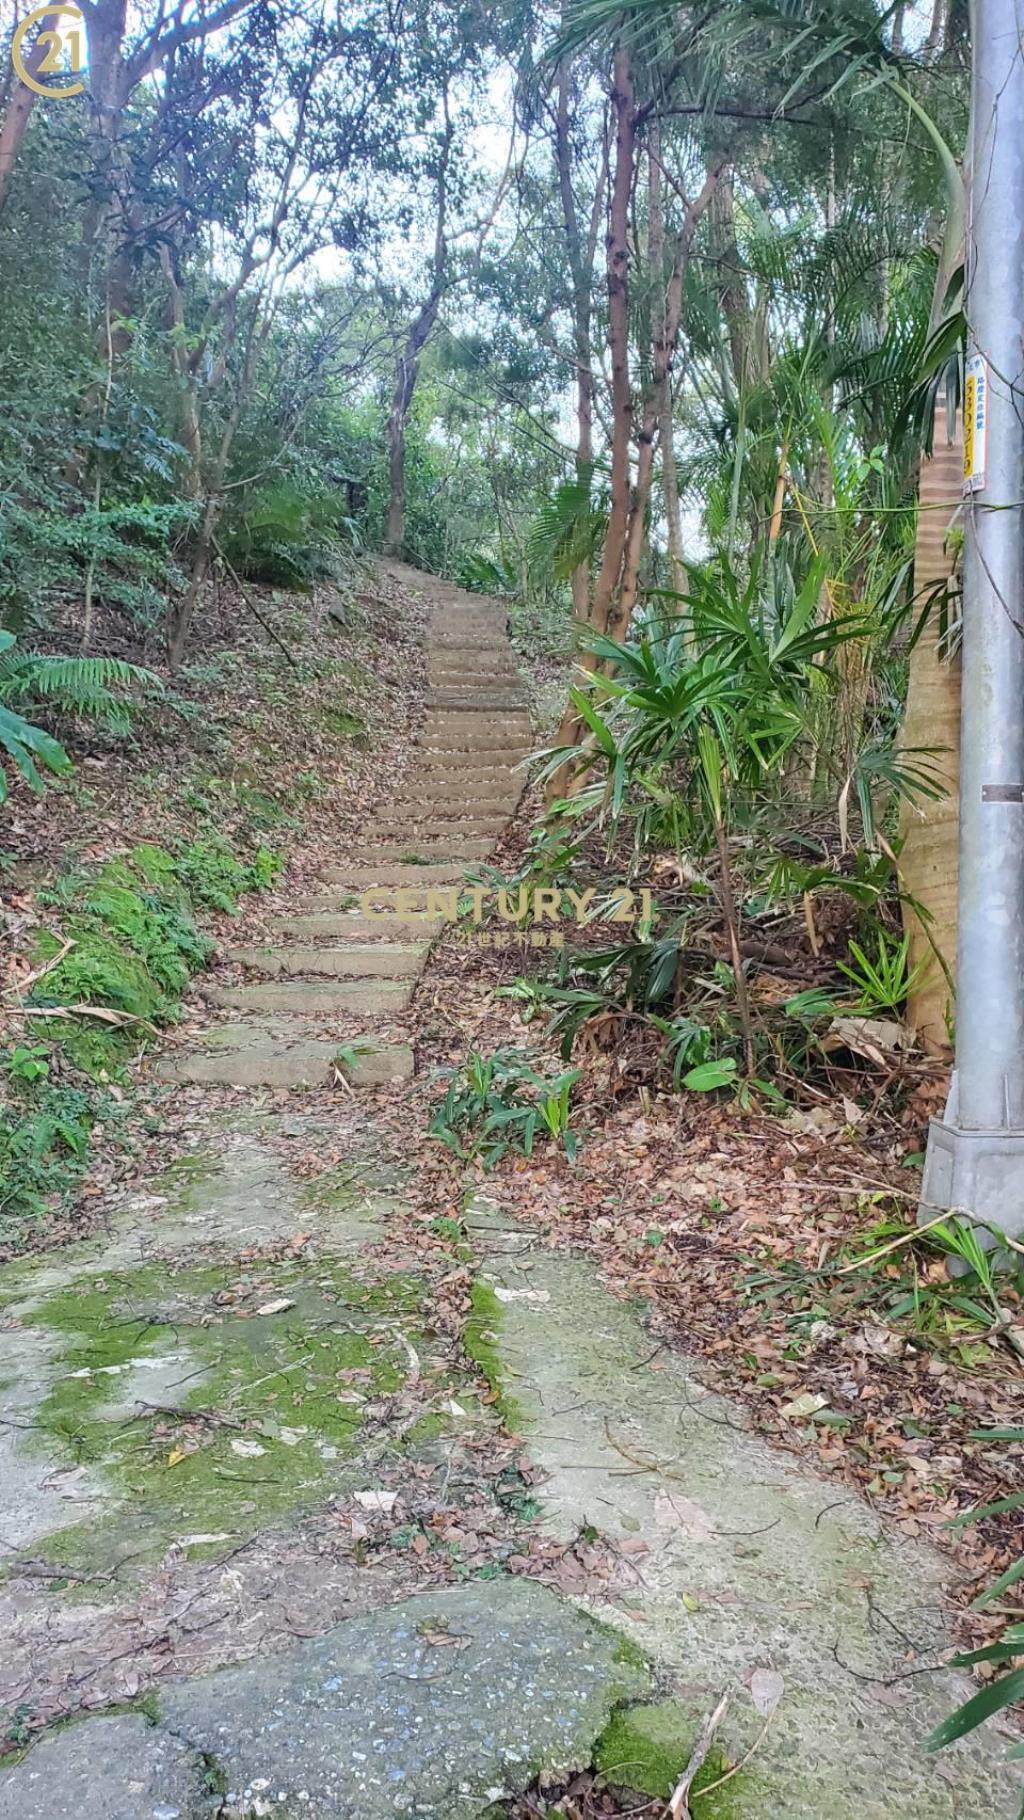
[156,1023,413,1087]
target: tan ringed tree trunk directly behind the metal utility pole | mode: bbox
[900,414,962,1054]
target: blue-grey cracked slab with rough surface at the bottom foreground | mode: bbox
[162,1578,649,1820]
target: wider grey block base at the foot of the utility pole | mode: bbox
[917,1083,1024,1238]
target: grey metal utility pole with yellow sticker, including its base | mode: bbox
[922,0,1024,1234]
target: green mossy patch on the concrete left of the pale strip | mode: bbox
[8,1258,435,1576]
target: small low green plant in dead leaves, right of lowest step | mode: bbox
[429,1048,580,1168]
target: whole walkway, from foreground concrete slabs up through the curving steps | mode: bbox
[0,568,1020,1820]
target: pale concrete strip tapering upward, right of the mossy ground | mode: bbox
[467,1198,1024,1820]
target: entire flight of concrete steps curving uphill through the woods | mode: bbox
[160,562,531,1087]
